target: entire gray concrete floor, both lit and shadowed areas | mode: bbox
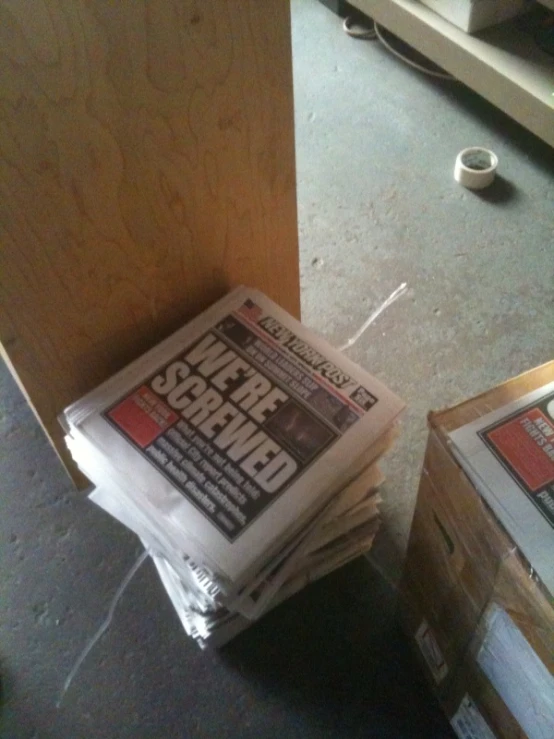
[0,0,554,739]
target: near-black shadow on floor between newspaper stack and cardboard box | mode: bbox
[221,558,452,739]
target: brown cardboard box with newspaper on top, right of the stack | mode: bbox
[400,362,554,739]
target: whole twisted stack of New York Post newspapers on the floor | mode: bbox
[61,288,403,647]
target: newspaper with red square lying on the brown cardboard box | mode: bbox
[450,382,554,595]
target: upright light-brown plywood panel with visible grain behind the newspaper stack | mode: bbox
[0,0,299,482]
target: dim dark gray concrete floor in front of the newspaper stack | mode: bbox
[0,366,450,739]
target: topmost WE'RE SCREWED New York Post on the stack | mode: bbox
[63,288,403,593]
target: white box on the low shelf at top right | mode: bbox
[421,0,531,33]
